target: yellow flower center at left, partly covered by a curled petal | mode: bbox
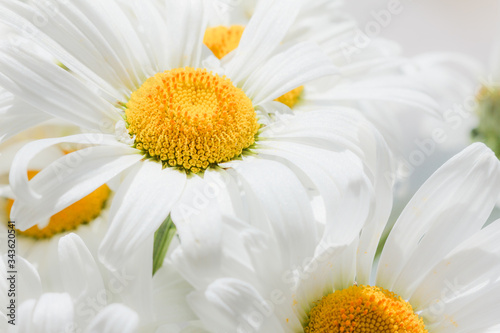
[6,171,110,239]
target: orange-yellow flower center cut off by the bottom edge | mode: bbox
[304,286,427,333]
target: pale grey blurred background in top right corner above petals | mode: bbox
[345,0,500,63]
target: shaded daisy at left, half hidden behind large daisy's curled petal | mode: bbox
[0,122,112,290]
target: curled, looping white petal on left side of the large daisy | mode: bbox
[10,134,142,230]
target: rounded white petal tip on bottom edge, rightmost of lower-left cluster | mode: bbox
[85,303,139,333]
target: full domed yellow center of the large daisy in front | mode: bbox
[125,67,260,173]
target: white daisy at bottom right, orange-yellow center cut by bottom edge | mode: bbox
[173,143,500,333]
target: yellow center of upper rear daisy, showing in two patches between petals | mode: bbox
[203,25,304,108]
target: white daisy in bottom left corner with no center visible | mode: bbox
[0,234,196,333]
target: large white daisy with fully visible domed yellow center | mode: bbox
[0,0,391,267]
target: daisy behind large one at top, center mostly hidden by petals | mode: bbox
[204,0,439,120]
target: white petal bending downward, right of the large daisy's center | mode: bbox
[256,140,373,244]
